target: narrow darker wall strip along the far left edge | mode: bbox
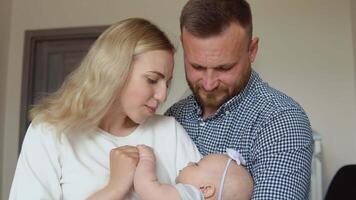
[0,0,11,197]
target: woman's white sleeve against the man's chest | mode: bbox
[175,121,202,174]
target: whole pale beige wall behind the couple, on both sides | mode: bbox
[0,0,356,199]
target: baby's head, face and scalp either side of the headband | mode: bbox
[176,154,253,200]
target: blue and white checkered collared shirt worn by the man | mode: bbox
[166,71,313,200]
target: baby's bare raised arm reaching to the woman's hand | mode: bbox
[134,145,181,200]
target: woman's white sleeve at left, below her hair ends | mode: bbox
[9,124,62,200]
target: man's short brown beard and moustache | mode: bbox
[187,81,238,110]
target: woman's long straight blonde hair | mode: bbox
[30,18,175,133]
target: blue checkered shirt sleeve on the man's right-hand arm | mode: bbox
[251,109,313,200]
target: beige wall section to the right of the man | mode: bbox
[250,0,356,195]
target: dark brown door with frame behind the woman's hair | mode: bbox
[19,26,107,150]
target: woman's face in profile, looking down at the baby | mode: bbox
[119,50,174,124]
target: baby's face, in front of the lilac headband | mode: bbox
[176,154,227,188]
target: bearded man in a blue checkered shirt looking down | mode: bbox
[166,0,313,200]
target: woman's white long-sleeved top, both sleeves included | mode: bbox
[9,115,200,200]
